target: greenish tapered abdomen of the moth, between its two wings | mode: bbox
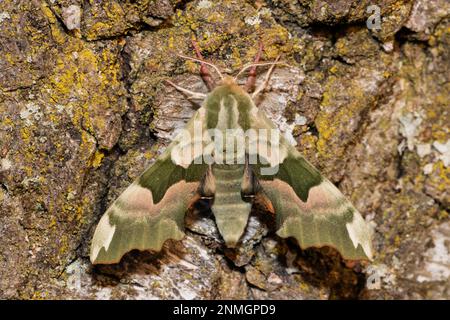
[211,165,251,247]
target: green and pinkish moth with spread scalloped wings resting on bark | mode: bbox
[90,42,373,264]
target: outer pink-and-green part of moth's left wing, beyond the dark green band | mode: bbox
[90,181,198,264]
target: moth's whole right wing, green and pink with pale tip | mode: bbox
[252,111,373,260]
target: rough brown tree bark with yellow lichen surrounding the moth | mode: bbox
[0,0,450,299]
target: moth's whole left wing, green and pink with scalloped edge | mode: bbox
[90,108,211,264]
